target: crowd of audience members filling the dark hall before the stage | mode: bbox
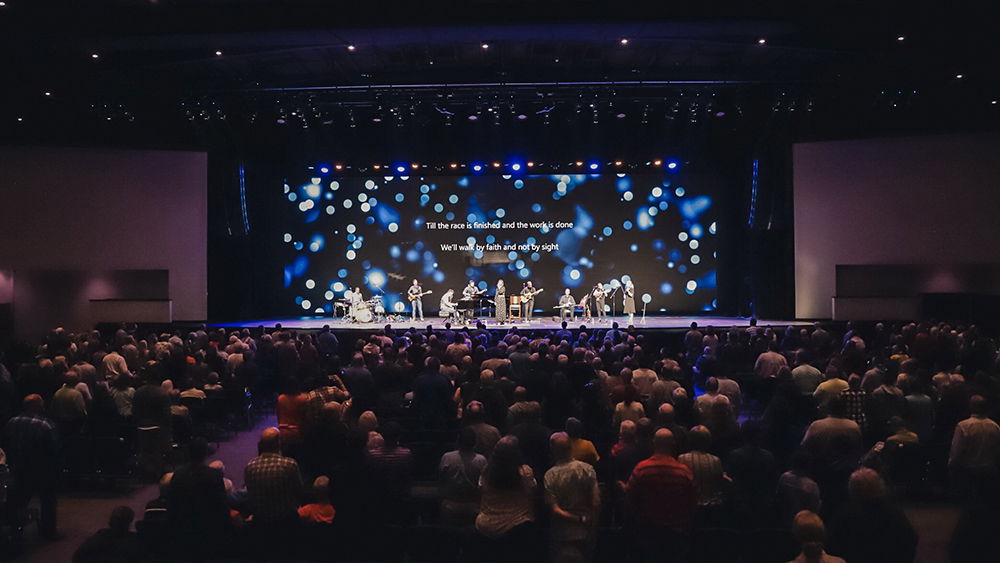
[0,323,1000,563]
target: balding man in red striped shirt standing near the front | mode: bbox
[620,428,697,561]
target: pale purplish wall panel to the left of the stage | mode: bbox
[0,148,208,338]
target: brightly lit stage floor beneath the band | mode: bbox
[209,316,807,331]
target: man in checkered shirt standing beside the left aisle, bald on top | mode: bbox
[243,428,302,524]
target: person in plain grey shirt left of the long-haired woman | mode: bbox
[438,426,487,526]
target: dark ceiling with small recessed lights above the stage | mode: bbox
[0,0,1000,154]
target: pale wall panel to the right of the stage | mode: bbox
[793,130,1000,318]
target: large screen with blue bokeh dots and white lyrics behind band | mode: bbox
[272,171,719,315]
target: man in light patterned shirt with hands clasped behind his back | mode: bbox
[544,432,601,560]
